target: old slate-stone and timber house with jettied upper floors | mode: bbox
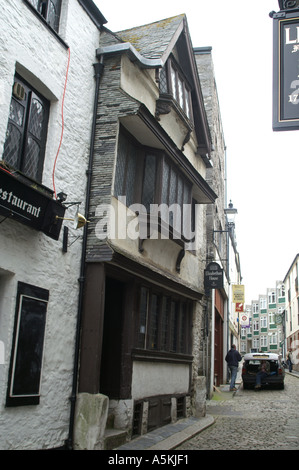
[76,15,225,448]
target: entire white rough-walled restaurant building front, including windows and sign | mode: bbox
[0,0,105,449]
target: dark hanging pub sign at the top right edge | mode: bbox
[272,9,299,131]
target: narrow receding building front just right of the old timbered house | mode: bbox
[195,47,242,397]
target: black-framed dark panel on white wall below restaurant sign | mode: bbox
[6,282,49,406]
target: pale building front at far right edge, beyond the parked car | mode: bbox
[283,254,299,371]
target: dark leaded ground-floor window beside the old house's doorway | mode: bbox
[137,286,192,354]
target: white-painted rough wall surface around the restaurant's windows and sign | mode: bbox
[0,0,99,449]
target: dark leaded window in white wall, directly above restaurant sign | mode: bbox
[2,75,49,183]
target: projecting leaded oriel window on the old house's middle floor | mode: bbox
[114,127,195,235]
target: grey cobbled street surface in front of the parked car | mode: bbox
[176,374,299,450]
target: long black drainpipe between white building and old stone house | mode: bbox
[65,57,104,450]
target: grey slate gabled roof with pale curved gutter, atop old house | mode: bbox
[96,14,211,160]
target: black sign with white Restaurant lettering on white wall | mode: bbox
[0,167,65,240]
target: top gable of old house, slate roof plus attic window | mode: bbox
[97,14,211,166]
